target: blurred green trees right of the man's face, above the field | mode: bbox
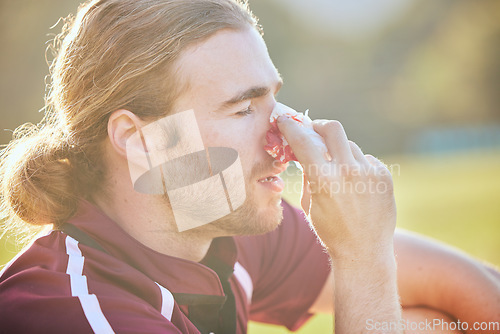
[254,0,500,154]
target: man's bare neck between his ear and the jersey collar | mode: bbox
[93,143,215,262]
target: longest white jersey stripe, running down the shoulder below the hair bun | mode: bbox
[66,236,114,334]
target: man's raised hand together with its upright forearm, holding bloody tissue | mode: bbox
[278,117,401,333]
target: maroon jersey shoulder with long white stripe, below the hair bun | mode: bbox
[0,231,188,333]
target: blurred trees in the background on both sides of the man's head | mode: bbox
[0,0,500,155]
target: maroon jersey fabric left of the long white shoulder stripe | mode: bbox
[0,232,91,333]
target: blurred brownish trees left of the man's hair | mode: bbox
[0,0,80,144]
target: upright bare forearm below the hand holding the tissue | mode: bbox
[333,249,401,334]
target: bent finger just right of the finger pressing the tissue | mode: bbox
[313,121,356,164]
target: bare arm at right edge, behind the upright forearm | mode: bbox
[395,231,500,330]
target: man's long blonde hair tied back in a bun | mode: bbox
[0,0,258,235]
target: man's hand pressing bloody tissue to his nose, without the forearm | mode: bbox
[279,117,396,265]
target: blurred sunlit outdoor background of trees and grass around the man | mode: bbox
[0,0,500,333]
